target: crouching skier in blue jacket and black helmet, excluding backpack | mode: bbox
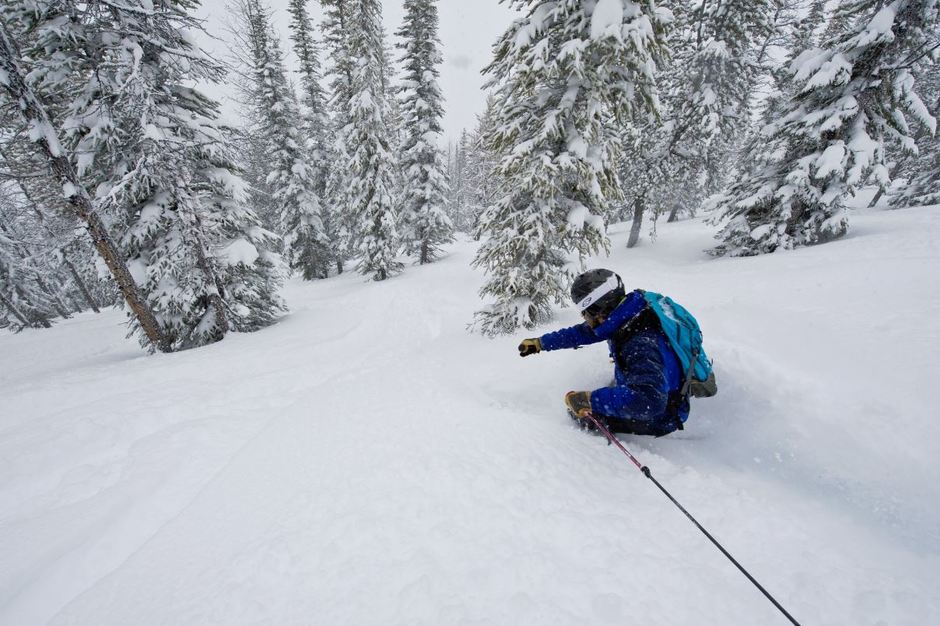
[519,269,689,437]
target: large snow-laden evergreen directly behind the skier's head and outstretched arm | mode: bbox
[474,0,668,335]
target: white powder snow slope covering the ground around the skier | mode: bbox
[0,207,940,626]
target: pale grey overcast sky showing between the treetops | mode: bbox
[199,0,514,144]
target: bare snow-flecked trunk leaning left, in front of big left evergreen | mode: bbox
[0,22,172,352]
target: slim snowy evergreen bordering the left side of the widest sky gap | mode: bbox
[397,0,453,264]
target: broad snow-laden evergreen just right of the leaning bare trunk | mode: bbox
[95,3,282,349]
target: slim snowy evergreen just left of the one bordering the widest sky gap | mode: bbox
[343,0,402,280]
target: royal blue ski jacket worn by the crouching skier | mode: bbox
[539,290,689,434]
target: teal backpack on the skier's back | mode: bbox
[643,291,718,398]
